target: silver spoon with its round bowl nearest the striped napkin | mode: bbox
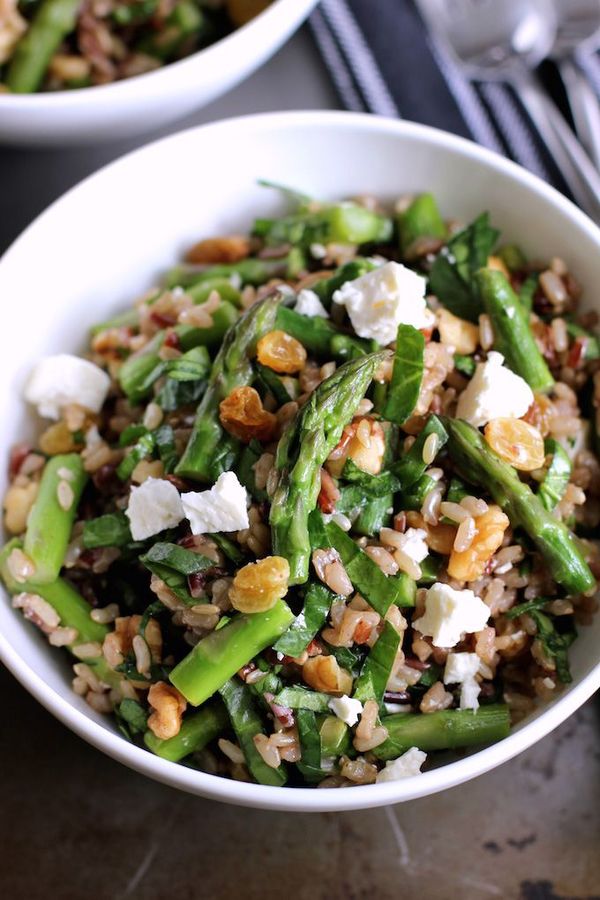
[417,0,600,221]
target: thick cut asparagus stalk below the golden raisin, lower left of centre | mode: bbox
[169,600,294,706]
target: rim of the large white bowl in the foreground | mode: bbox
[0,110,600,812]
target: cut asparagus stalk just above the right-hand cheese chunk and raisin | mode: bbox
[475,269,554,391]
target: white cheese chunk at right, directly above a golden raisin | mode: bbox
[456,351,533,428]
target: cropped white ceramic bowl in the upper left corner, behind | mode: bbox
[0,0,317,147]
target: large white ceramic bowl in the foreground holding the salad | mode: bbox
[0,112,600,812]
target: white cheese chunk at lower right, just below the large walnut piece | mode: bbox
[413,581,490,647]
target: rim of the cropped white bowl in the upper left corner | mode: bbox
[0,0,318,106]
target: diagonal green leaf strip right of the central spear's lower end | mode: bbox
[310,510,416,616]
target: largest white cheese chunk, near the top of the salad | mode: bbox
[333,262,435,346]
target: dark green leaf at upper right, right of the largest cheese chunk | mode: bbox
[429,213,499,322]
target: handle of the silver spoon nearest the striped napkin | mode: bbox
[515,75,600,222]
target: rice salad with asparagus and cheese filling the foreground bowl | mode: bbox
[0,185,600,788]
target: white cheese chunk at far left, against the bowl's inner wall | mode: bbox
[25,353,110,419]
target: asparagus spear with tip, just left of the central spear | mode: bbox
[175,296,282,483]
